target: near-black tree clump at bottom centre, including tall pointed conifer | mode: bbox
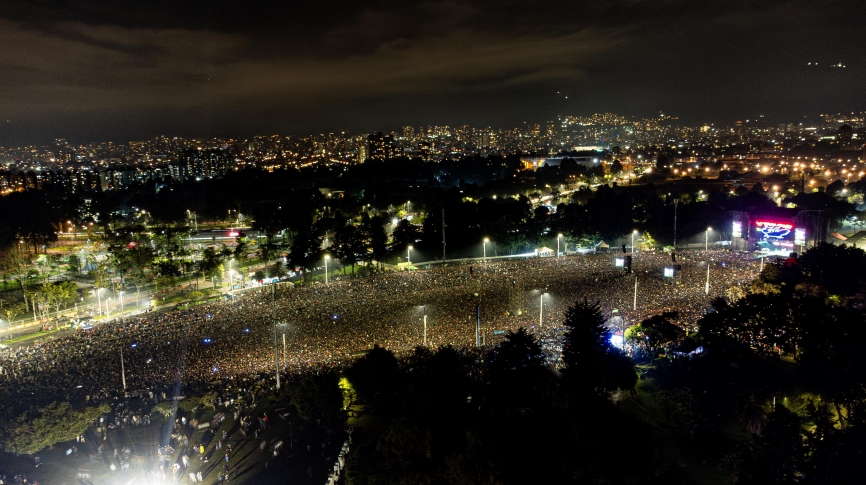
[345,302,665,485]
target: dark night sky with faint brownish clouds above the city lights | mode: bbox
[0,0,866,146]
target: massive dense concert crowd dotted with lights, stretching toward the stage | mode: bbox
[0,251,759,412]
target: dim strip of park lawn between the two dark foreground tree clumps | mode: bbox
[621,378,746,485]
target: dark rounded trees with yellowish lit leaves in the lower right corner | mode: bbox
[688,245,866,484]
